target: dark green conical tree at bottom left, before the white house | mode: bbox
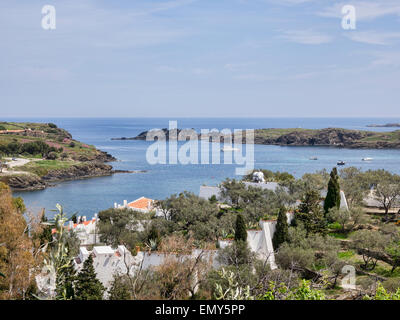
[75,255,105,300]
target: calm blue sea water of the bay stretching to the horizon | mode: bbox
[5,118,400,217]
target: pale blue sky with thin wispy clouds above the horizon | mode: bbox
[0,0,400,118]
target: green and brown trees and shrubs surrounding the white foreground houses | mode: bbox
[0,164,400,300]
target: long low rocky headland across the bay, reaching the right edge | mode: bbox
[114,128,400,149]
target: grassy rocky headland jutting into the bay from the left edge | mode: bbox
[0,122,124,191]
